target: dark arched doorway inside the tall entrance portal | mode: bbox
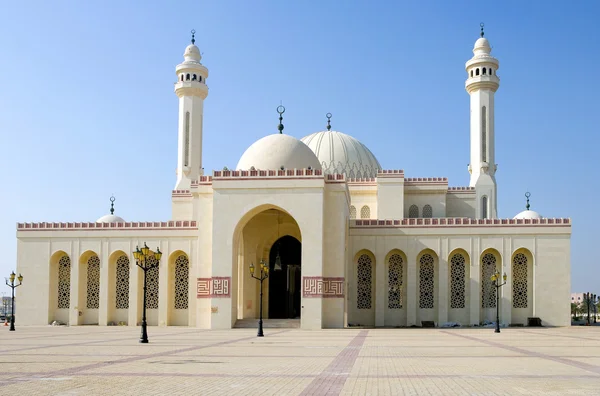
[269,236,302,319]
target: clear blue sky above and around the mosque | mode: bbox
[0,0,600,294]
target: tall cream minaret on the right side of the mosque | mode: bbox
[465,23,500,219]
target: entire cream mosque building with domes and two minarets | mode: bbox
[17,27,571,329]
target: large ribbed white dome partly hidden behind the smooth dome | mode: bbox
[302,131,381,178]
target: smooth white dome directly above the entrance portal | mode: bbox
[236,133,321,170]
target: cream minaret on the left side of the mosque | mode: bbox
[175,30,208,190]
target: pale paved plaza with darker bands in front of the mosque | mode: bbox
[0,326,600,396]
